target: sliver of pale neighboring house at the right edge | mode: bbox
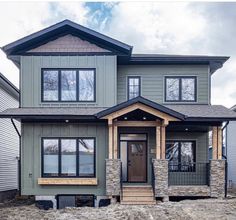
[226,106,236,190]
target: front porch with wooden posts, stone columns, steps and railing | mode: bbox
[97,97,225,204]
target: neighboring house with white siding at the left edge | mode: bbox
[0,73,19,202]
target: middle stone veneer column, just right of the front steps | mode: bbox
[152,159,168,199]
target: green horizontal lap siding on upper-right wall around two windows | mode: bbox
[117,65,210,104]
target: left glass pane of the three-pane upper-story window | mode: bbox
[43,70,58,101]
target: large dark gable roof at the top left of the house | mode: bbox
[2,20,132,56]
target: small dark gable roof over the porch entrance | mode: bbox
[96,96,185,120]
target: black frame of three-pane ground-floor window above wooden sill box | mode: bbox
[41,137,97,178]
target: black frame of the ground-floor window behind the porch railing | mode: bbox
[165,139,197,173]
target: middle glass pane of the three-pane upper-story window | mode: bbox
[61,70,76,101]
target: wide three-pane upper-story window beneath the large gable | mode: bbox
[42,69,95,102]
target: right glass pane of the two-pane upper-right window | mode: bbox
[181,78,195,101]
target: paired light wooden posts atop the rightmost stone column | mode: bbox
[212,126,222,160]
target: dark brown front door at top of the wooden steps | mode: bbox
[128,141,147,182]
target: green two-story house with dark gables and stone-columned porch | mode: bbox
[0,20,236,208]
